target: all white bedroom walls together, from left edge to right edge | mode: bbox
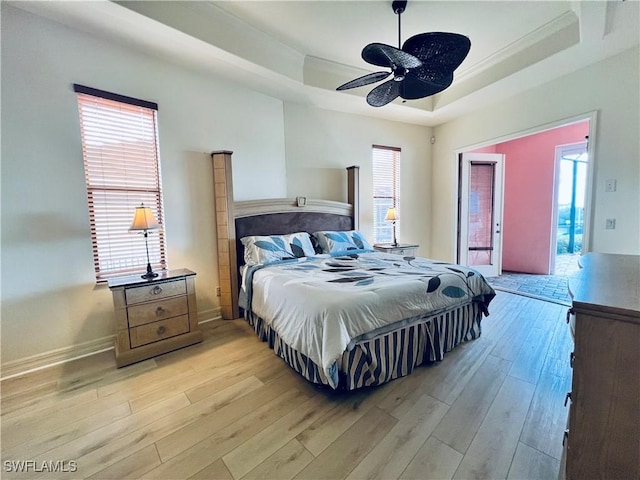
[5,3,640,372]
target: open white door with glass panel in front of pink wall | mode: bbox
[458,153,504,277]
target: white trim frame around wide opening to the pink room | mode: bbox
[450,110,598,272]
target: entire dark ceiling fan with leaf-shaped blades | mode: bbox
[336,0,471,107]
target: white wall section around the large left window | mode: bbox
[1,4,286,365]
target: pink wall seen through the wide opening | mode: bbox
[495,121,589,275]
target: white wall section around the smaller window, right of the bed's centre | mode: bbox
[285,103,431,256]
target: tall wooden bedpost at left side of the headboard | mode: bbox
[211,150,240,320]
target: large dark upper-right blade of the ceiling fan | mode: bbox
[402,32,471,72]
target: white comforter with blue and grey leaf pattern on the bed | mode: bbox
[240,252,495,388]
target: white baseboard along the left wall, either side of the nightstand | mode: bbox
[0,307,222,381]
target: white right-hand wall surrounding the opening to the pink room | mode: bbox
[431,48,640,260]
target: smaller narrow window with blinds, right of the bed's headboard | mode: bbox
[373,145,401,243]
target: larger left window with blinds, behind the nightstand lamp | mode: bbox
[74,85,167,281]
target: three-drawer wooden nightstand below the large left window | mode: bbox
[109,269,202,367]
